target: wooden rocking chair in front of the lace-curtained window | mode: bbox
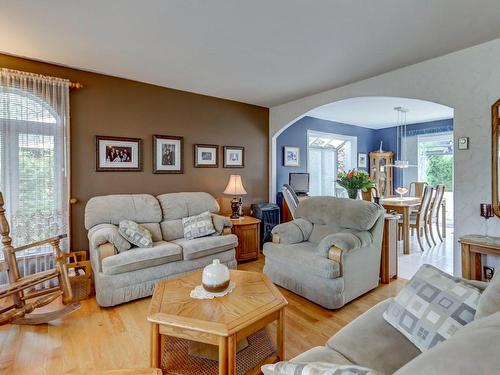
[0,193,80,325]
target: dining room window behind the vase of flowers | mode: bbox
[307,130,357,196]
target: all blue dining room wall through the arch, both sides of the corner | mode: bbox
[276,116,453,192]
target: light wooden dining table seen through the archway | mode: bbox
[380,196,446,254]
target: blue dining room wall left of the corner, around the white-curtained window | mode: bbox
[276,116,378,192]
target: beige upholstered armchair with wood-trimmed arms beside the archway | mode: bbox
[264,197,384,309]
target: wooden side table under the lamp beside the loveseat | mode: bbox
[231,216,260,262]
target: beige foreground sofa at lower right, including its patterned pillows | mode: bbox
[263,265,500,375]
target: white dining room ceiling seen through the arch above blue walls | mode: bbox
[306,96,453,129]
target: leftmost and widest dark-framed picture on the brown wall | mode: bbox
[96,135,142,172]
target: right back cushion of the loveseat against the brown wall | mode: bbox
[156,192,219,220]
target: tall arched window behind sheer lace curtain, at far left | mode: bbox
[0,86,67,252]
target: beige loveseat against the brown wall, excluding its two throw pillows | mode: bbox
[85,192,238,306]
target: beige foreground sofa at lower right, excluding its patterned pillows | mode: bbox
[263,280,500,375]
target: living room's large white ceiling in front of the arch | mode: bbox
[0,0,500,106]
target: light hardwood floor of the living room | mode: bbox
[0,258,405,375]
